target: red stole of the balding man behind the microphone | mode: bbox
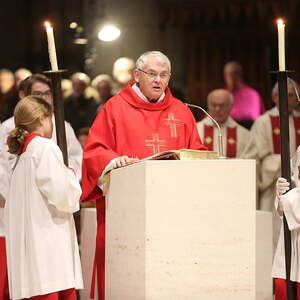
[203,125,237,158]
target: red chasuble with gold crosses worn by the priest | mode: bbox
[82,82,206,300]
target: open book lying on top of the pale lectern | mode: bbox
[140,149,218,161]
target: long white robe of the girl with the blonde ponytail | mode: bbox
[5,137,83,299]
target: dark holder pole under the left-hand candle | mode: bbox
[43,70,68,166]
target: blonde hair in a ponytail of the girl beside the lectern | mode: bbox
[7,96,52,154]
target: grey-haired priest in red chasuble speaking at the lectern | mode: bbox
[82,51,206,300]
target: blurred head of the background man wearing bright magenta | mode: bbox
[224,61,243,91]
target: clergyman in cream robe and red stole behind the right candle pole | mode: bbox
[251,78,300,249]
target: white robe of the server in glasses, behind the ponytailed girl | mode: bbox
[0,116,82,236]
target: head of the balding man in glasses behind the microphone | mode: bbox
[207,89,233,124]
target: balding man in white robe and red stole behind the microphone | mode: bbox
[197,89,250,158]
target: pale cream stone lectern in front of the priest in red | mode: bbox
[106,159,256,300]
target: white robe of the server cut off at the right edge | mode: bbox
[272,147,300,282]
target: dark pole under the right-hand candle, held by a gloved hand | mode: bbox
[277,71,297,300]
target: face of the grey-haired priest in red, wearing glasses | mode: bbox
[134,56,170,100]
